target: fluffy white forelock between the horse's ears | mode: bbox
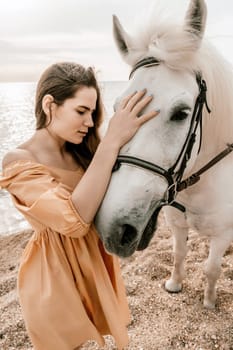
[129,13,201,69]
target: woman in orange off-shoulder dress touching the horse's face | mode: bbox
[0,62,158,350]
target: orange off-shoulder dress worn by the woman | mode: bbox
[0,160,130,350]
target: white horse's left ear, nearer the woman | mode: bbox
[113,15,131,58]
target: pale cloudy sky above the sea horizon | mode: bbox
[0,0,233,82]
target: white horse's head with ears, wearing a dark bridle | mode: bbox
[96,0,206,257]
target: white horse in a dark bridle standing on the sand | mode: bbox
[96,0,233,308]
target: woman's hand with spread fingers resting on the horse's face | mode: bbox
[104,90,159,149]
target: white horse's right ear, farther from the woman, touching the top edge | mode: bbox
[185,0,207,46]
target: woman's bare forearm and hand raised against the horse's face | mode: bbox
[71,91,159,223]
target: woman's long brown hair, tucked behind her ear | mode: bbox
[35,62,103,169]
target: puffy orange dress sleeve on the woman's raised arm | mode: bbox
[0,162,90,237]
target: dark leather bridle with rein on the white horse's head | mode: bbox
[113,57,233,212]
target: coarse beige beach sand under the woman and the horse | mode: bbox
[0,213,233,350]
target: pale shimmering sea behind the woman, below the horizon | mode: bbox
[0,81,127,235]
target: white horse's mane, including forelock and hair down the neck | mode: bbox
[125,1,233,150]
